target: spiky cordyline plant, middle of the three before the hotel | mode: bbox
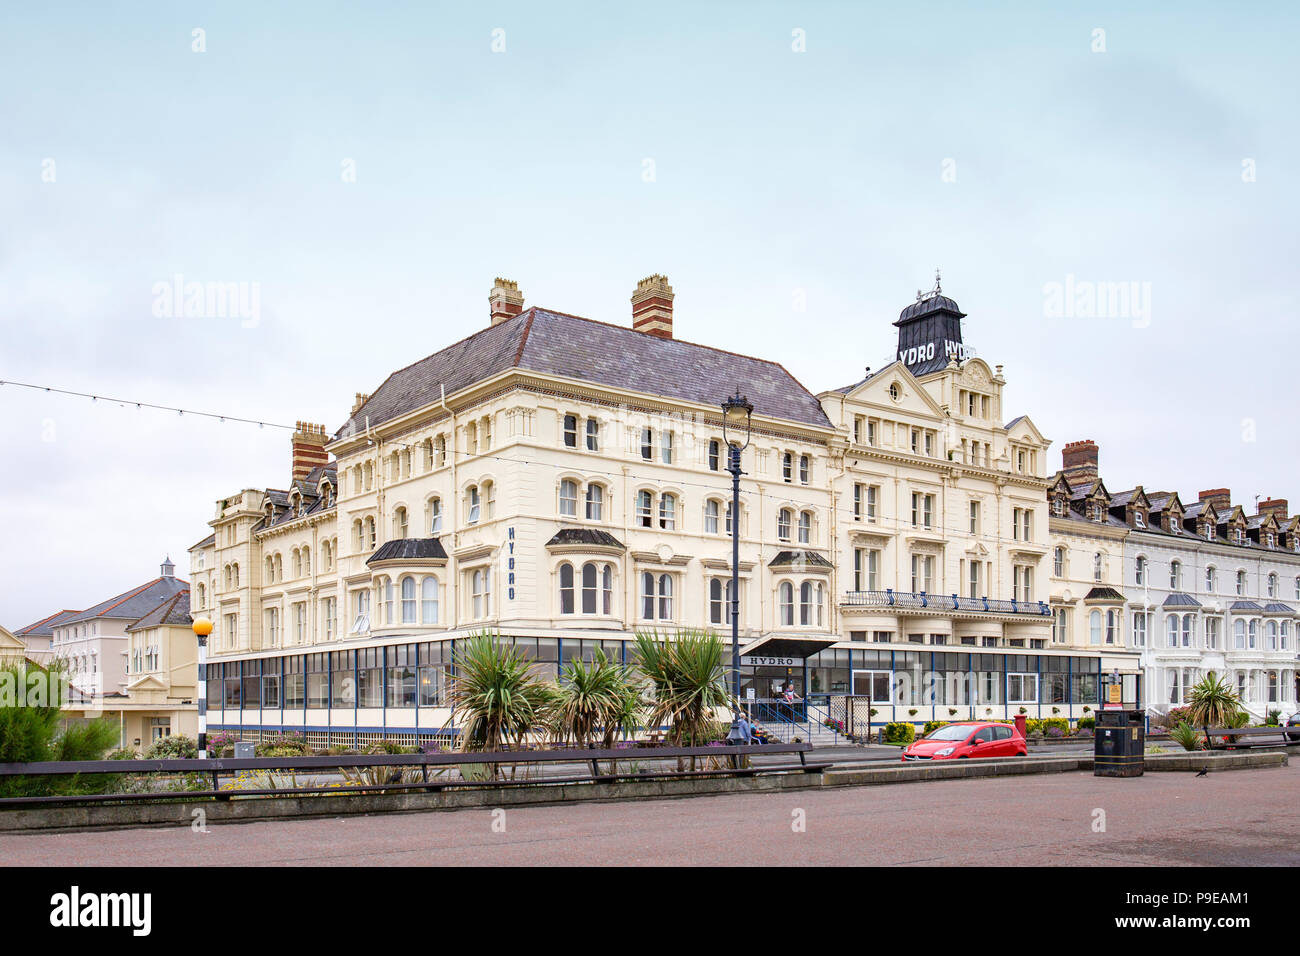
[551,650,641,749]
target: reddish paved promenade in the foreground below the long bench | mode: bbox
[0,766,1300,866]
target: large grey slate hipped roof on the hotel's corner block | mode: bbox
[335,308,831,437]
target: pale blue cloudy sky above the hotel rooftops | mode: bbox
[0,3,1300,627]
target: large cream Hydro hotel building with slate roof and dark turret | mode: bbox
[190,276,1138,745]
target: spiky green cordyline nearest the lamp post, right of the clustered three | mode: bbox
[636,628,731,747]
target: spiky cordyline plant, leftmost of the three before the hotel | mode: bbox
[447,632,555,752]
